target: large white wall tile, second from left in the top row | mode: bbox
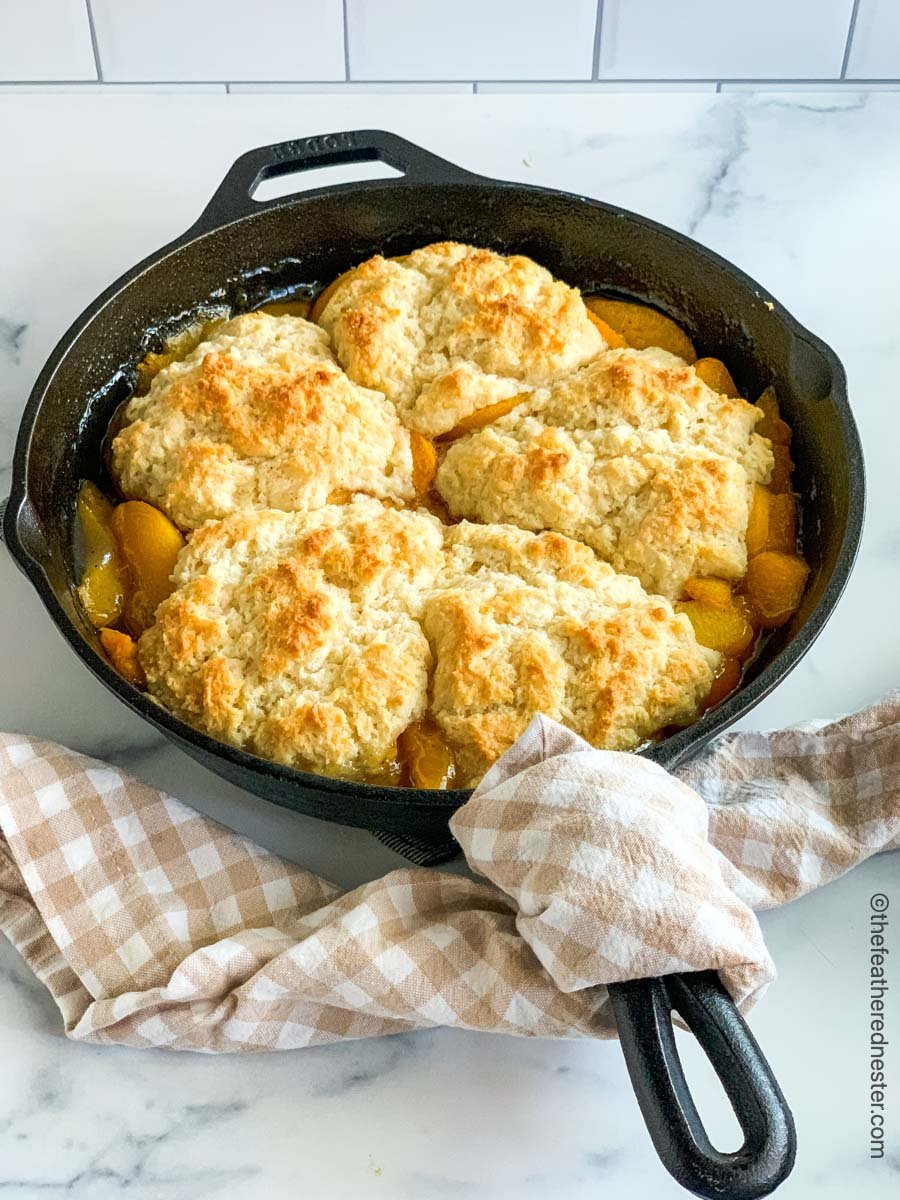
[91,0,344,80]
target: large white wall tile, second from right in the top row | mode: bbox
[600,0,854,79]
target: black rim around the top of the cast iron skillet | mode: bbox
[4,133,865,820]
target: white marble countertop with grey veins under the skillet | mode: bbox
[0,91,900,1200]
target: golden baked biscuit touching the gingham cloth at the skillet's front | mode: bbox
[424,522,719,785]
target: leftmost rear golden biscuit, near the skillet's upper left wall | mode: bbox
[112,313,415,529]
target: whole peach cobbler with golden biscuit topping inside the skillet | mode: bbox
[78,242,809,787]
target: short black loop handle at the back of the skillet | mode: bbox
[193,130,480,233]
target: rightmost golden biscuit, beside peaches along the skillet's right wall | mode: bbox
[436,350,773,598]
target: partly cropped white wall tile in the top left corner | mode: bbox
[0,0,97,82]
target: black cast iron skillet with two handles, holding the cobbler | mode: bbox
[4,131,864,1200]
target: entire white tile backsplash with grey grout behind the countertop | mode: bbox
[0,0,900,88]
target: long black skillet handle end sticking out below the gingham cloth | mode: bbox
[610,971,797,1200]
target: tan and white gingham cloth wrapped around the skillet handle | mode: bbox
[0,694,900,1051]
